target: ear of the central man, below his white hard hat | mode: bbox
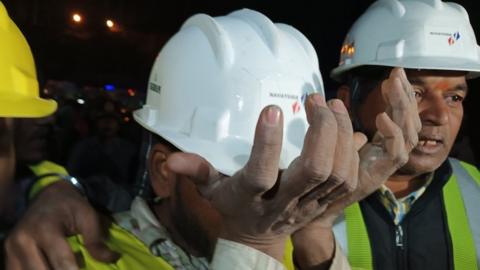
[148,143,174,198]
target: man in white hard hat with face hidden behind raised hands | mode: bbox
[5,7,418,269]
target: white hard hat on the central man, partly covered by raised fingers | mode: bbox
[134,9,324,175]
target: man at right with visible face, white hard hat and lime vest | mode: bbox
[292,0,480,269]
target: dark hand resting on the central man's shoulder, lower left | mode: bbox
[5,178,118,269]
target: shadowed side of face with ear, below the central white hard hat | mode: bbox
[149,143,222,258]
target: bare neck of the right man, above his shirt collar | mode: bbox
[385,174,427,198]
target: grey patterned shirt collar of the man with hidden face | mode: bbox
[114,197,208,270]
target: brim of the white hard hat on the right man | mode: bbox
[330,57,480,82]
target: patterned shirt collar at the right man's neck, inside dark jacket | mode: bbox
[378,173,433,225]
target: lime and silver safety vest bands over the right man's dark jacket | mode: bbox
[333,158,480,270]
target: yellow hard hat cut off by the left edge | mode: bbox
[0,2,57,117]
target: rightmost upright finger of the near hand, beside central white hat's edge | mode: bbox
[328,99,357,194]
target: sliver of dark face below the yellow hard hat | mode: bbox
[0,118,15,208]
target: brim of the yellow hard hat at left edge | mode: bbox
[0,97,57,118]
